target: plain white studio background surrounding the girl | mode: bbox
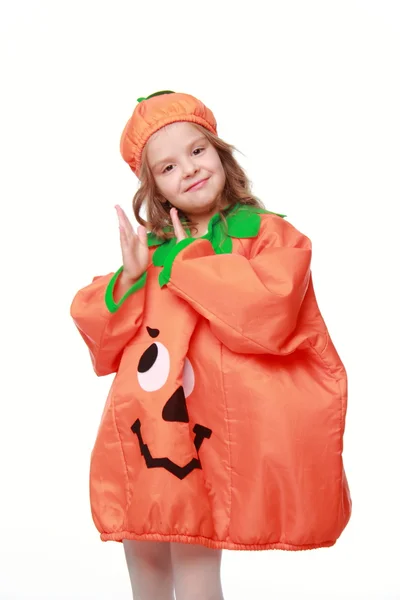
[0,0,400,600]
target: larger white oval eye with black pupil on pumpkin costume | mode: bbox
[137,342,170,392]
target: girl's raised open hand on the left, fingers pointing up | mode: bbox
[115,204,149,281]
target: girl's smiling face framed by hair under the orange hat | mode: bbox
[147,121,225,216]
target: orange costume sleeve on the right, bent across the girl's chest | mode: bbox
[159,215,311,355]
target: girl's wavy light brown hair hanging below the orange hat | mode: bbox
[132,123,264,240]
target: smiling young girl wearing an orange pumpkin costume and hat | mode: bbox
[71,91,352,600]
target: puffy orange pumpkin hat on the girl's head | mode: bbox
[120,90,217,177]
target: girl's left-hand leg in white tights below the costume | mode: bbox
[123,540,174,600]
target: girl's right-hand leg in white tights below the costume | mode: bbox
[171,542,224,600]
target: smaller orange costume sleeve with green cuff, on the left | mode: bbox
[70,267,147,376]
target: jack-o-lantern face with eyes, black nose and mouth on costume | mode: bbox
[131,327,212,479]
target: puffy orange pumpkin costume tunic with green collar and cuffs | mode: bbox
[71,91,351,550]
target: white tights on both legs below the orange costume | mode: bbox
[123,540,224,600]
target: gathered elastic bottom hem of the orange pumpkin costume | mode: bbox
[100,531,336,551]
